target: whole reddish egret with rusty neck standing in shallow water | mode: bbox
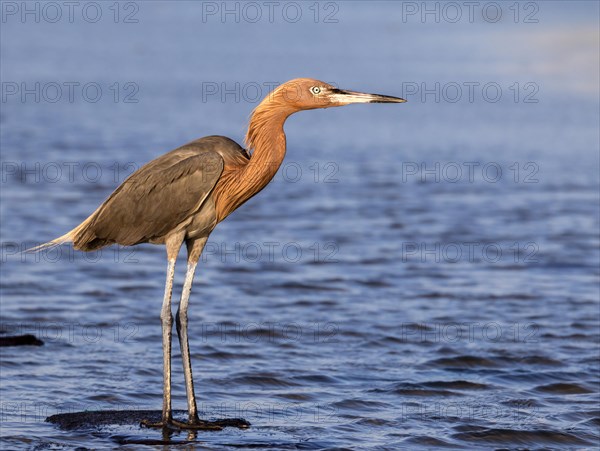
[34,78,405,429]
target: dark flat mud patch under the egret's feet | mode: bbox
[46,410,250,431]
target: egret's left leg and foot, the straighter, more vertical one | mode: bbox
[142,257,175,428]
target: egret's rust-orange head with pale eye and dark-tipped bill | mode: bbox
[271,78,406,111]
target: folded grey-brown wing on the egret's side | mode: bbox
[73,146,224,250]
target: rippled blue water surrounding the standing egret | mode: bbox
[0,2,600,450]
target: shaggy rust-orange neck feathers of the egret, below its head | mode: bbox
[214,90,296,221]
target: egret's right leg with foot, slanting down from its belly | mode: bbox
[174,238,222,430]
